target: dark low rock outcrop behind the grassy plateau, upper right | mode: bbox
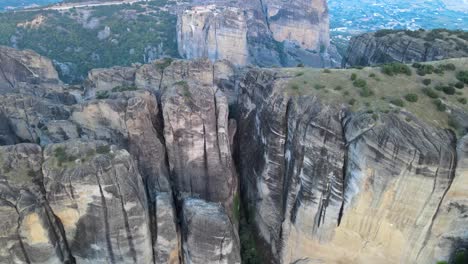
[343,30,468,67]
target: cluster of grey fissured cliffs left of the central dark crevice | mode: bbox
[0,47,240,264]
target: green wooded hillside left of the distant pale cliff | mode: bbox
[0,1,178,82]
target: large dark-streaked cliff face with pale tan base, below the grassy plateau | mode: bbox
[238,70,467,263]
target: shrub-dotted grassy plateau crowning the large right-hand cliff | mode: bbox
[282,58,468,130]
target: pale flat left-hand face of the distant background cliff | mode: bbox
[177,6,249,65]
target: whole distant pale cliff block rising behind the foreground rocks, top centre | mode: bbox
[177,0,341,67]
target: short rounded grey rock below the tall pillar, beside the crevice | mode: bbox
[182,198,241,264]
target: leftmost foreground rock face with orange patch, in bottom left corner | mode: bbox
[0,144,74,263]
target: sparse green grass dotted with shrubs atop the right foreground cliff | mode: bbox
[286,58,468,128]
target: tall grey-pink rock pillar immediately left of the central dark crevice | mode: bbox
[161,61,237,208]
